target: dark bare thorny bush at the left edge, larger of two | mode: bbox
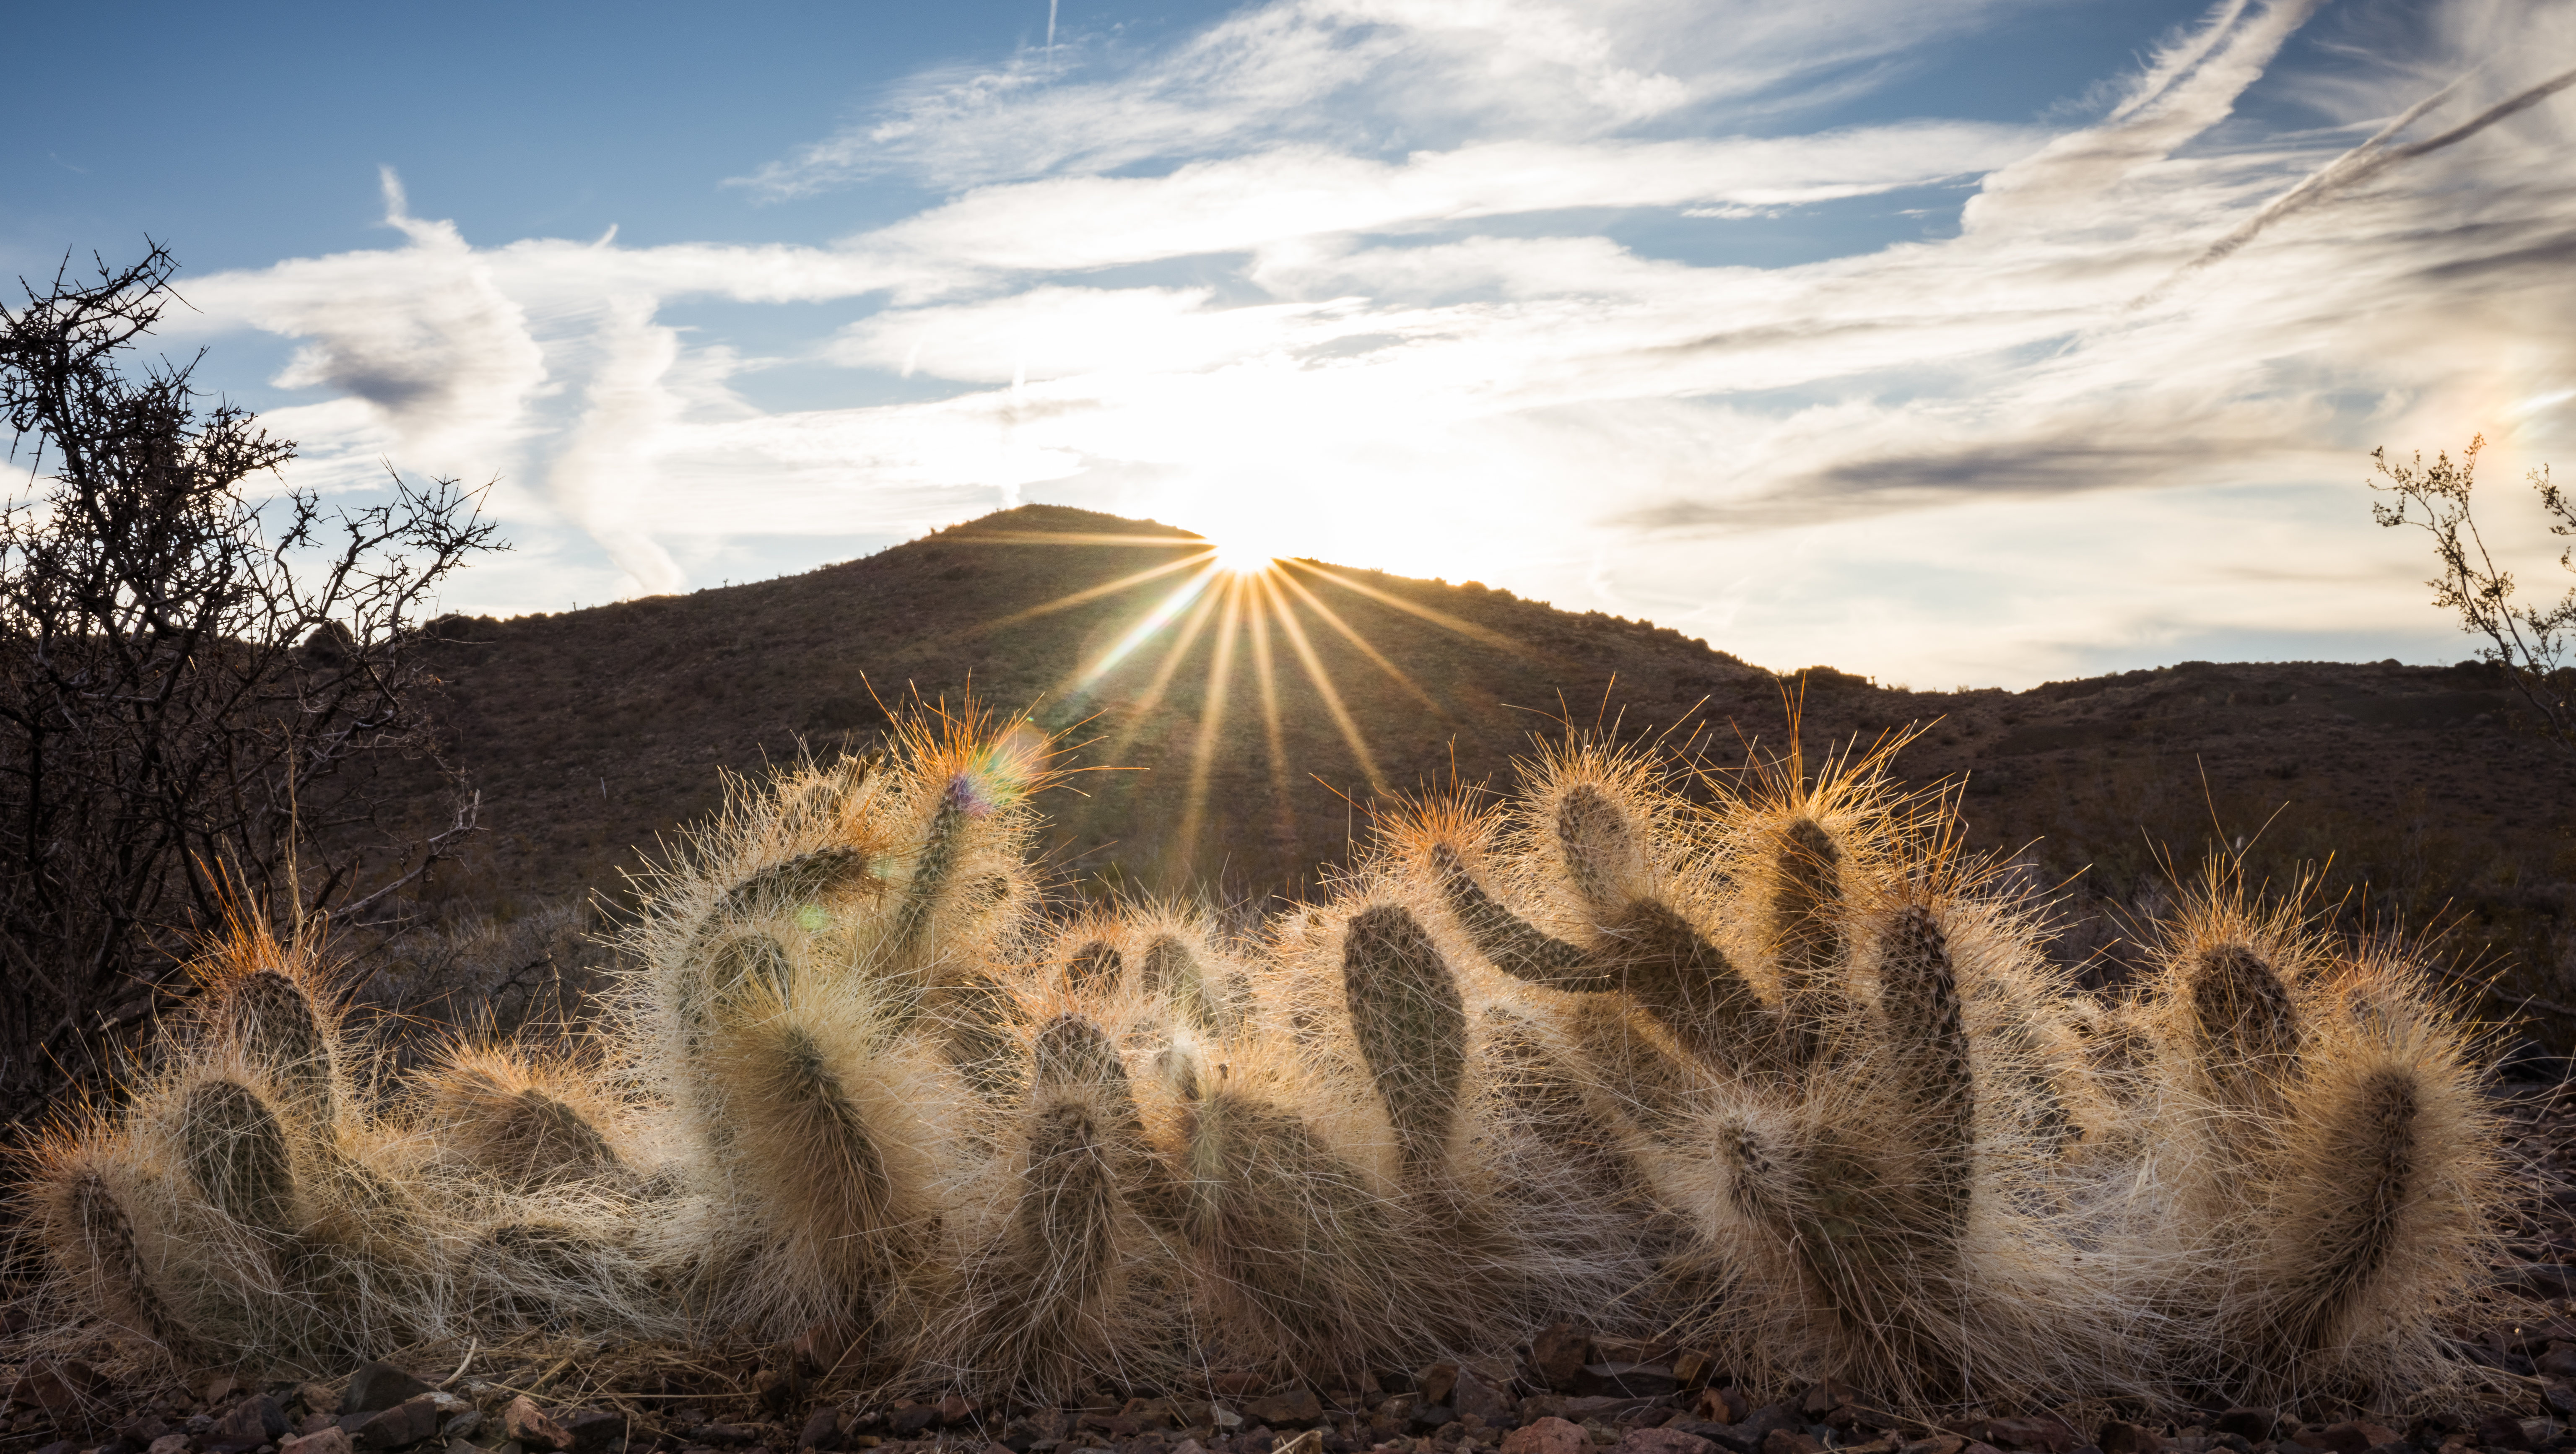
[0,245,500,1140]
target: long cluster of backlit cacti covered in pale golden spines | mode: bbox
[29,717,2511,1407]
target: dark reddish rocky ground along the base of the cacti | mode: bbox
[0,1083,2576,1454]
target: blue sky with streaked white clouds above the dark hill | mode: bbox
[0,0,2576,688]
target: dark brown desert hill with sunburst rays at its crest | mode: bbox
[386,505,2576,1041]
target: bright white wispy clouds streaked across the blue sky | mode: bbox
[166,0,2576,678]
